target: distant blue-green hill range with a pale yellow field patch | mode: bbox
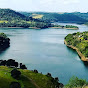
[20,12,88,23]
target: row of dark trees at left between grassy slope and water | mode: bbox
[0,59,27,69]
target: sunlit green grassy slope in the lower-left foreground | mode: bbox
[0,66,58,88]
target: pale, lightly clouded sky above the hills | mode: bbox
[0,0,88,12]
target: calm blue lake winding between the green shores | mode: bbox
[0,23,88,84]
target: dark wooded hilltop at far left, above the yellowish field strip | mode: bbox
[0,9,27,21]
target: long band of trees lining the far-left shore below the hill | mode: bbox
[0,20,51,29]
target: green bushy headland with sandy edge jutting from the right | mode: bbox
[64,31,88,62]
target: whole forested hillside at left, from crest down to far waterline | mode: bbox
[0,9,51,28]
